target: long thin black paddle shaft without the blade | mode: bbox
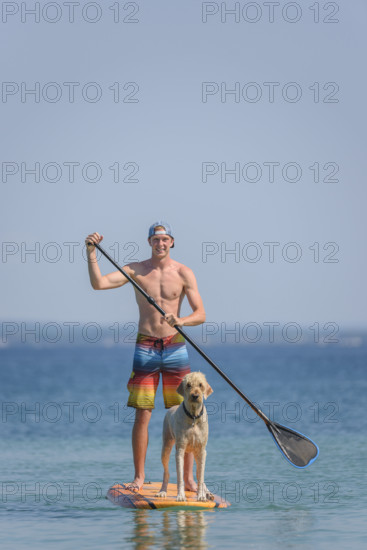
[89,243,270,425]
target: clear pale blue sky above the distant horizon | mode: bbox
[0,0,367,336]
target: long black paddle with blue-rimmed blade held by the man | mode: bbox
[88,243,319,468]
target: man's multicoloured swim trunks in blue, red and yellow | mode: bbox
[127,332,190,409]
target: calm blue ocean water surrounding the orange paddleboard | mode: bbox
[0,344,367,550]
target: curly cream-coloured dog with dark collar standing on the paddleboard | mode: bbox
[156,372,213,501]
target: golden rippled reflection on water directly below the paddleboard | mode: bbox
[124,510,215,550]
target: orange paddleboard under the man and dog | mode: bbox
[107,481,231,509]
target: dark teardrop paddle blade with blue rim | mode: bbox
[266,422,319,468]
